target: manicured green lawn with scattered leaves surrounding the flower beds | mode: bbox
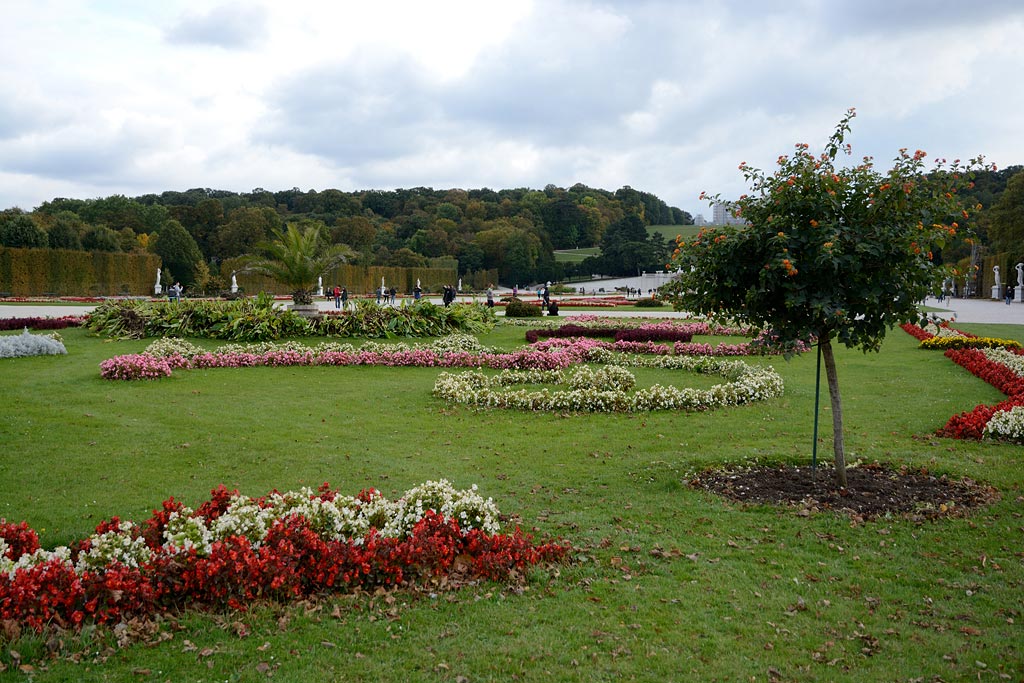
[0,325,1024,682]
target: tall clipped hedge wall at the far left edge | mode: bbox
[0,247,160,296]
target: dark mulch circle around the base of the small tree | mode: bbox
[690,463,999,519]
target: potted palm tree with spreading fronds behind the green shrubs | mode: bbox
[243,223,354,306]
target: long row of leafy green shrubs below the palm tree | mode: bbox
[86,296,496,342]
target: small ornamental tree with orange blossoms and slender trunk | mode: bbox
[669,109,982,487]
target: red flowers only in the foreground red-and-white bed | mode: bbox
[0,486,570,631]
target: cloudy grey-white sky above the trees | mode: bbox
[0,0,1024,216]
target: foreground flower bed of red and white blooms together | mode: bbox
[0,480,570,631]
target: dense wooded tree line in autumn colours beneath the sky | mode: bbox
[0,183,693,285]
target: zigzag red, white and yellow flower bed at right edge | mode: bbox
[901,324,1024,442]
